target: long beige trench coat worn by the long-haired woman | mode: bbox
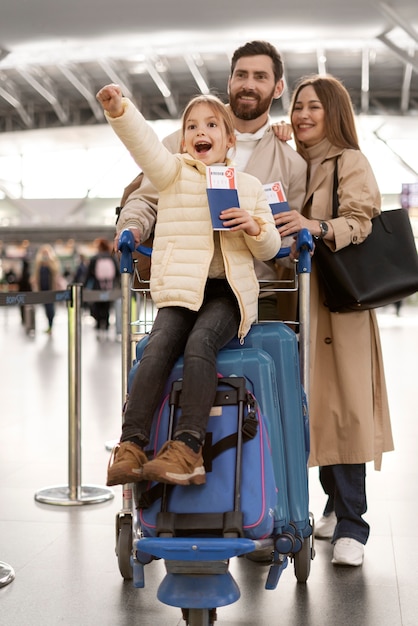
[303,142,393,470]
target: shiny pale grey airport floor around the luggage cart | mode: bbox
[0,306,418,626]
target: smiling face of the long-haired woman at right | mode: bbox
[291,85,326,147]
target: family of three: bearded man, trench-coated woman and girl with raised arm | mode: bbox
[97,41,393,566]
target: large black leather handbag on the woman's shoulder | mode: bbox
[313,166,418,313]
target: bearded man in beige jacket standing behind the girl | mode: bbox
[115,41,307,319]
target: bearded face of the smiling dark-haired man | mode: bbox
[228,54,283,120]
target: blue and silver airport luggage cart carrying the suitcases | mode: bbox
[116,230,314,626]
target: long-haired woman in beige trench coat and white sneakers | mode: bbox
[279,76,393,566]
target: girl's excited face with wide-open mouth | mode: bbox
[183,102,233,165]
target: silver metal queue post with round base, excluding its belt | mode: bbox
[35,284,114,506]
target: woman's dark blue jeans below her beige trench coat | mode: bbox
[319,463,370,544]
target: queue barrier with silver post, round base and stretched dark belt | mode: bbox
[0,284,115,506]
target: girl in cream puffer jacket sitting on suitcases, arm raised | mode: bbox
[97,85,280,485]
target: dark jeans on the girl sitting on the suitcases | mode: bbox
[121,279,240,444]
